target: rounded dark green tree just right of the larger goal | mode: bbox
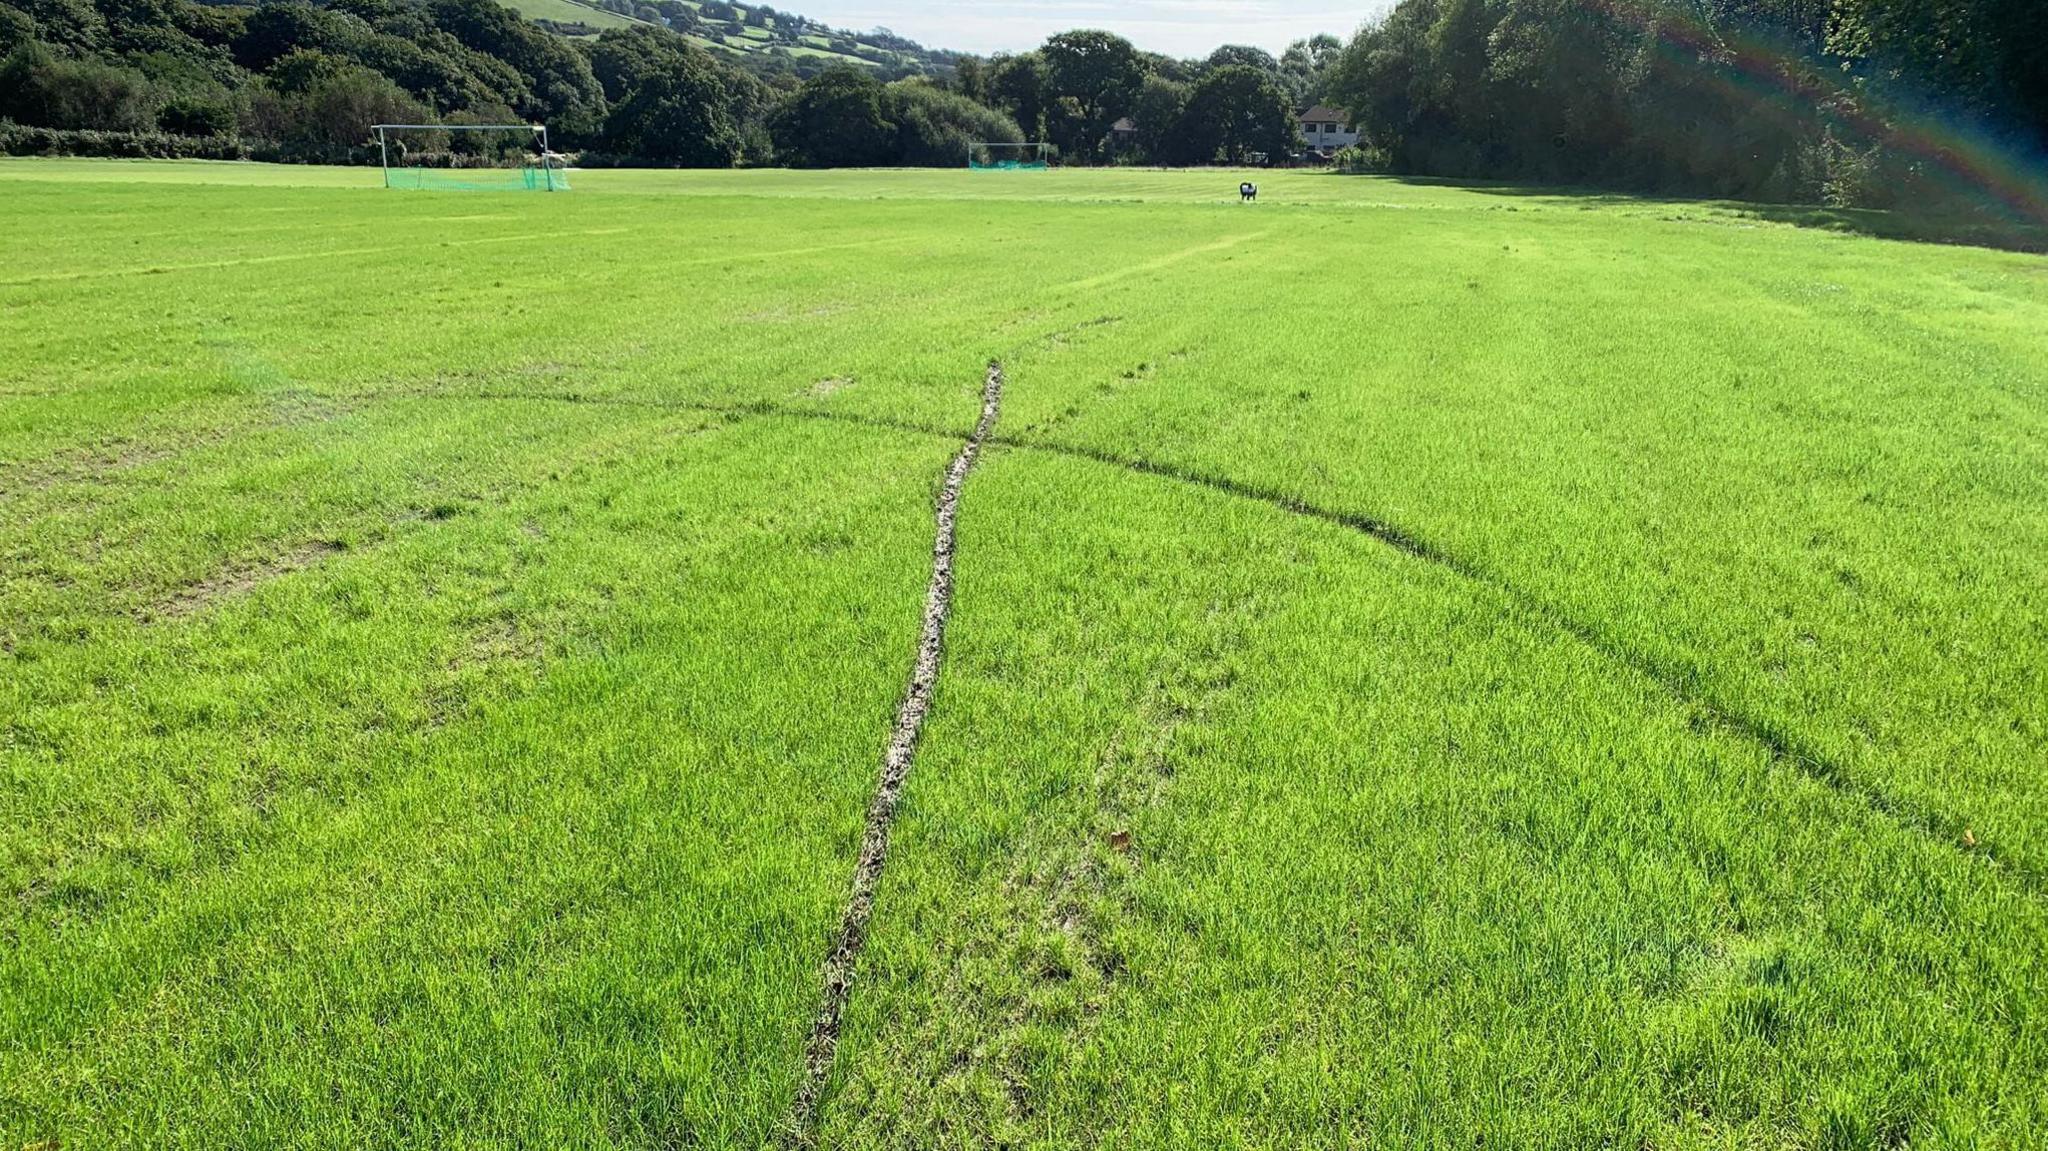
[604,49,743,168]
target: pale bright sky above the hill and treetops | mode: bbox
[774,0,1393,57]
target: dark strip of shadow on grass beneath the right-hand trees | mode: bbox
[1343,172,2048,252]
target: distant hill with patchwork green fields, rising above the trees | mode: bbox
[500,0,958,76]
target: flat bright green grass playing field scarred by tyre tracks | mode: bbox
[12,160,2048,1149]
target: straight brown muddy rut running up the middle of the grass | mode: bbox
[788,363,1004,1147]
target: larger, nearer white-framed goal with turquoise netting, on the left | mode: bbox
[375,123,569,193]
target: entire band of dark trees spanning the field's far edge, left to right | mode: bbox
[0,0,2048,219]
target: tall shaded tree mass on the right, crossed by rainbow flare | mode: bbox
[1327,0,2048,215]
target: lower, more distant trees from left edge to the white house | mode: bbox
[0,0,1339,166]
